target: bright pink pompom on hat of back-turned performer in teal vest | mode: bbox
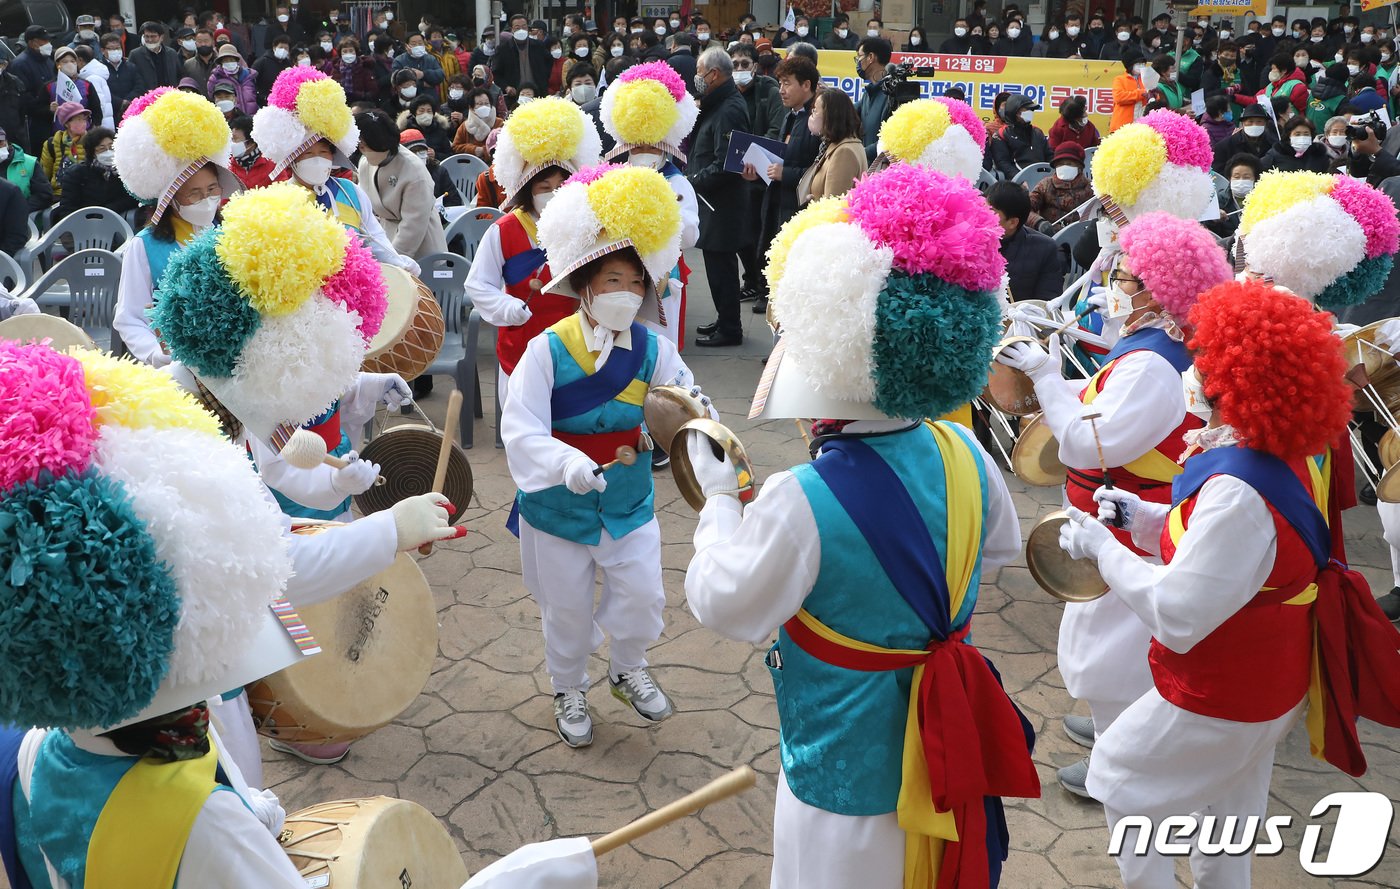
[833,164,1007,290]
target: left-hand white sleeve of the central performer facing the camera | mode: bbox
[501,336,582,493]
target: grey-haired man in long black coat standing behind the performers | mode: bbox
[686,46,757,346]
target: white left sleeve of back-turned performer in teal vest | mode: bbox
[686,473,822,643]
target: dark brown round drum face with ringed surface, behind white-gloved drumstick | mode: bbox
[354,424,472,522]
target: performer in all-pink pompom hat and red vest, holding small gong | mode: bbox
[997,213,1231,797]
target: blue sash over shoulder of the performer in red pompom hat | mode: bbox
[1172,445,1331,568]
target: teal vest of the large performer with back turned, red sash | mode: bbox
[769,424,987,815]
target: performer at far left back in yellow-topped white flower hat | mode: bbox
[112,87,242,367]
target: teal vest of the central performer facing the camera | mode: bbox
[515,327,657,546]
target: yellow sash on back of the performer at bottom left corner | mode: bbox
[84,745,218,889]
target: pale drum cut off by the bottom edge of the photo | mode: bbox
[277,797,468,889]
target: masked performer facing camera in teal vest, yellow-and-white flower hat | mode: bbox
[501,163,699,748]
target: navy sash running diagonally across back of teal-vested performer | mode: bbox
[812,438,952,640]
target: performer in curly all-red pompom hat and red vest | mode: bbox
[1060,283,1400,889]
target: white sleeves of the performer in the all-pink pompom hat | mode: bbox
[1036,350,1186,469]
